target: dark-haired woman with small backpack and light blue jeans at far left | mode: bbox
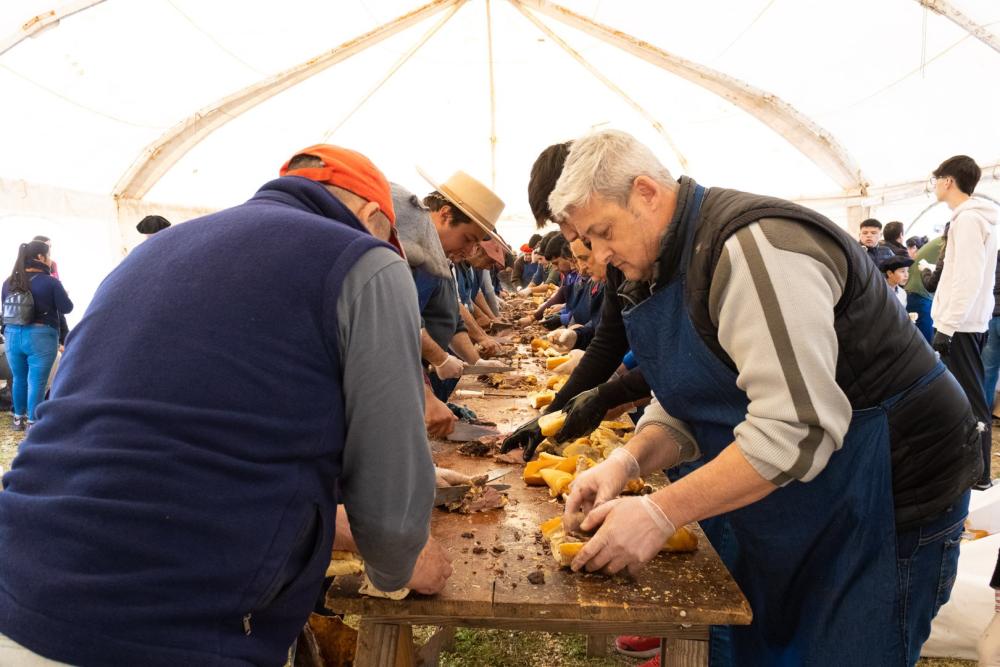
[2,241,73,431]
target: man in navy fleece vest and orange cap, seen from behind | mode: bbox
[0,145,451,667]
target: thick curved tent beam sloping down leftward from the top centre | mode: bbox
[114,0,466,199]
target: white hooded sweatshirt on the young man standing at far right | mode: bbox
[931,197,1000,336]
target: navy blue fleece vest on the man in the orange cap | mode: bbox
[0,176,390,667]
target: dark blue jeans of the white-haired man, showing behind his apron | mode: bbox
[896,491,970,665]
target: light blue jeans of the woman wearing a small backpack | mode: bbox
[5,324,59,422]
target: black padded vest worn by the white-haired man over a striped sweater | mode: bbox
[640,177,976,528]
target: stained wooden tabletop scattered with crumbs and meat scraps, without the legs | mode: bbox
[326,346,751,628]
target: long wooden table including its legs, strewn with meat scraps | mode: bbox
[326,362,752,667]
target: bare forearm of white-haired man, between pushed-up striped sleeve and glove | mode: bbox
[652,444,778,528]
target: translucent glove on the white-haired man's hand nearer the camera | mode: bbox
[571,494,676,575]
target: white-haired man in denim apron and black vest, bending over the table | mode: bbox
[549,131,981,665]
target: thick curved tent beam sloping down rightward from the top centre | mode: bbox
[509,0,868,193]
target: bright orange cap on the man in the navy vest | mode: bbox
[278,144,404,255]
